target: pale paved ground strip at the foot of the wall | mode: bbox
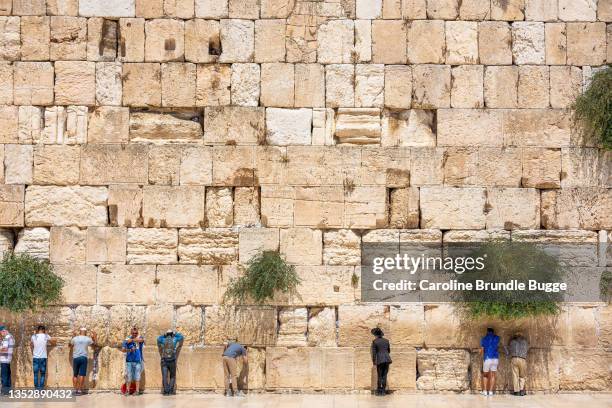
[2,393,612,408]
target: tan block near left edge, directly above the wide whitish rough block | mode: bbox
[32,145,80,185]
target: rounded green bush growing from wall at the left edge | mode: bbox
[0,252,64,313]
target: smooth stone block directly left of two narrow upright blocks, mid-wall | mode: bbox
[142,186,204,228]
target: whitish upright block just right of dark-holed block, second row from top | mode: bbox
[219,19,255,62]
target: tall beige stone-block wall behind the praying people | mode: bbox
[0,0,612,391]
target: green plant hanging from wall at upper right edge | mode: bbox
[574,66,612,150]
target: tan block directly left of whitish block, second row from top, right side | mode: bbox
[478,21,512,65]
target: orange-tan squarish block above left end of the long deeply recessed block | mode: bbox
[123,63,161,106]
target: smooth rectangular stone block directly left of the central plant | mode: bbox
[157,265,219,305]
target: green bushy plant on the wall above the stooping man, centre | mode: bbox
[223,251,300,304]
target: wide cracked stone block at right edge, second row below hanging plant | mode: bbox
[541,188,612,230]
